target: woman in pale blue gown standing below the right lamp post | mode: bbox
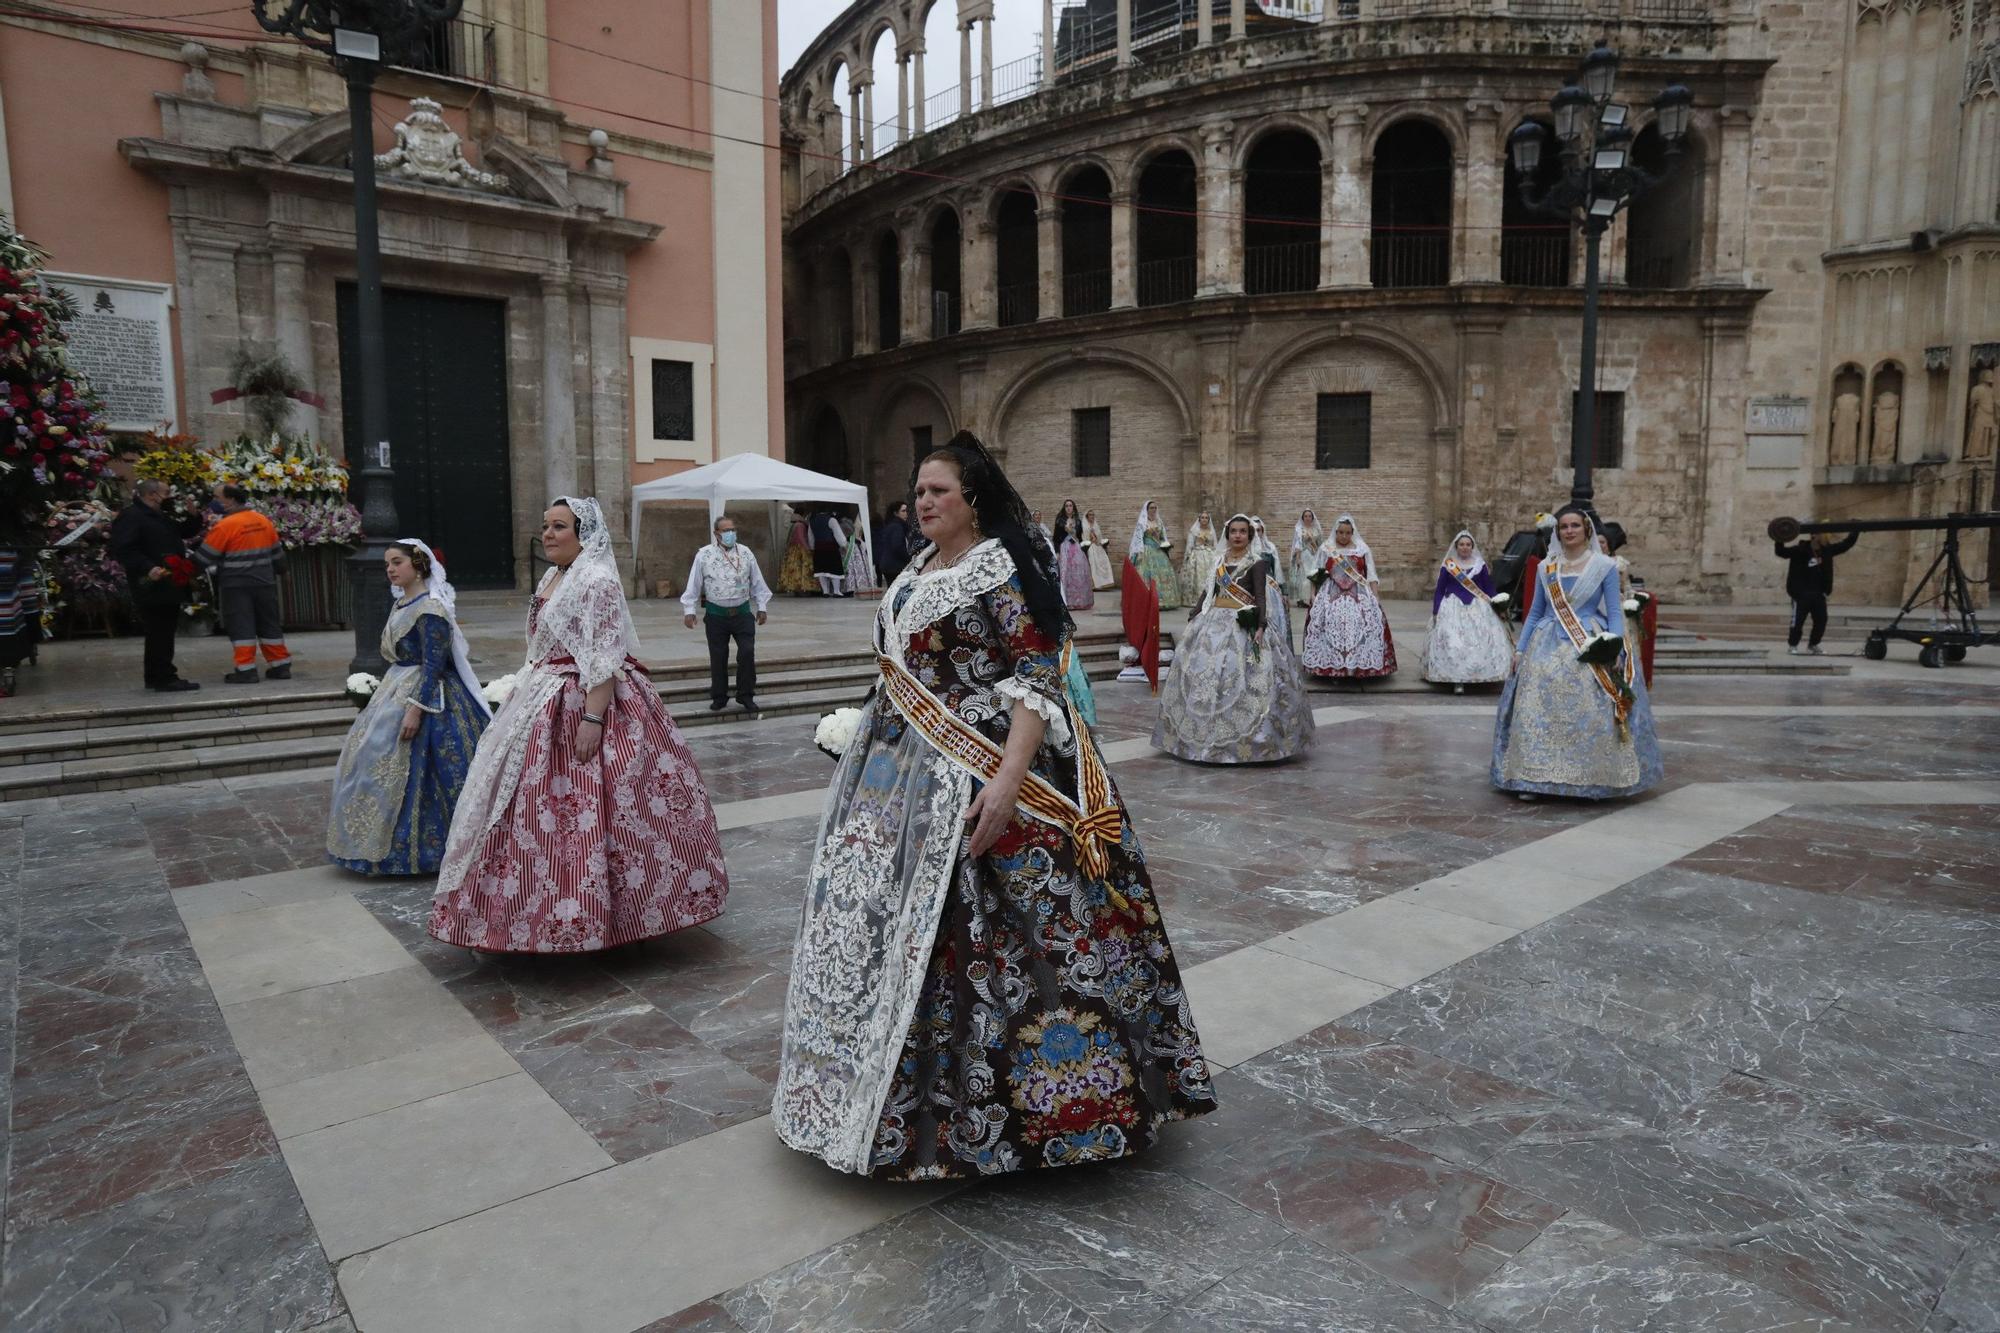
[1492,504,1662,801]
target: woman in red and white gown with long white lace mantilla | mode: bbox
[430,496,728,953]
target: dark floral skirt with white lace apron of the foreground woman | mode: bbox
[772,697,1216,1181]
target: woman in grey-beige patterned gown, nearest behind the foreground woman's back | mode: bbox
[1152,514,1312,765]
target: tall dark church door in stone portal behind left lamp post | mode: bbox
[338,282,514,588]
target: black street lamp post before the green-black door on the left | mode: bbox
[250,0,464,675]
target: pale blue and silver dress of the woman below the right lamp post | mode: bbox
[1492,554,1664,801]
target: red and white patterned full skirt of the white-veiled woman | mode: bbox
[430,658,730,953]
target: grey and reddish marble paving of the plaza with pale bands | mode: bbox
[0,652,2000,1333]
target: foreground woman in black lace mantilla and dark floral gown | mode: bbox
[772,432,1216,1181]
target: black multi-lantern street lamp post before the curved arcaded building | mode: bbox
[1508,42,1694,512]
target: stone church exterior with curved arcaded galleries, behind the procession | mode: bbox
[780,0,2000,602]
